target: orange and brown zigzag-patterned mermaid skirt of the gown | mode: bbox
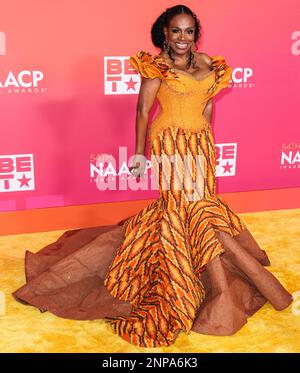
[104,126,246,347]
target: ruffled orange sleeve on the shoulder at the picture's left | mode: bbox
[129,50,177,80]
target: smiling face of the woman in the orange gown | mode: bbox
[164,14,195,54]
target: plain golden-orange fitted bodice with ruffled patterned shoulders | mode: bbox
[130,51,232,141]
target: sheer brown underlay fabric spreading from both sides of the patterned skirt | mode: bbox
[13,221,292,335]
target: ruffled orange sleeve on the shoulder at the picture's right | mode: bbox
[207,55,232,97]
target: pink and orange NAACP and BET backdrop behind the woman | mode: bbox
[0,0,300,211]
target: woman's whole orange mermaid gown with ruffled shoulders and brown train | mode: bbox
[13,51,292,347]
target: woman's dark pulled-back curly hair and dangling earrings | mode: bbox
[151,4,201,69]
